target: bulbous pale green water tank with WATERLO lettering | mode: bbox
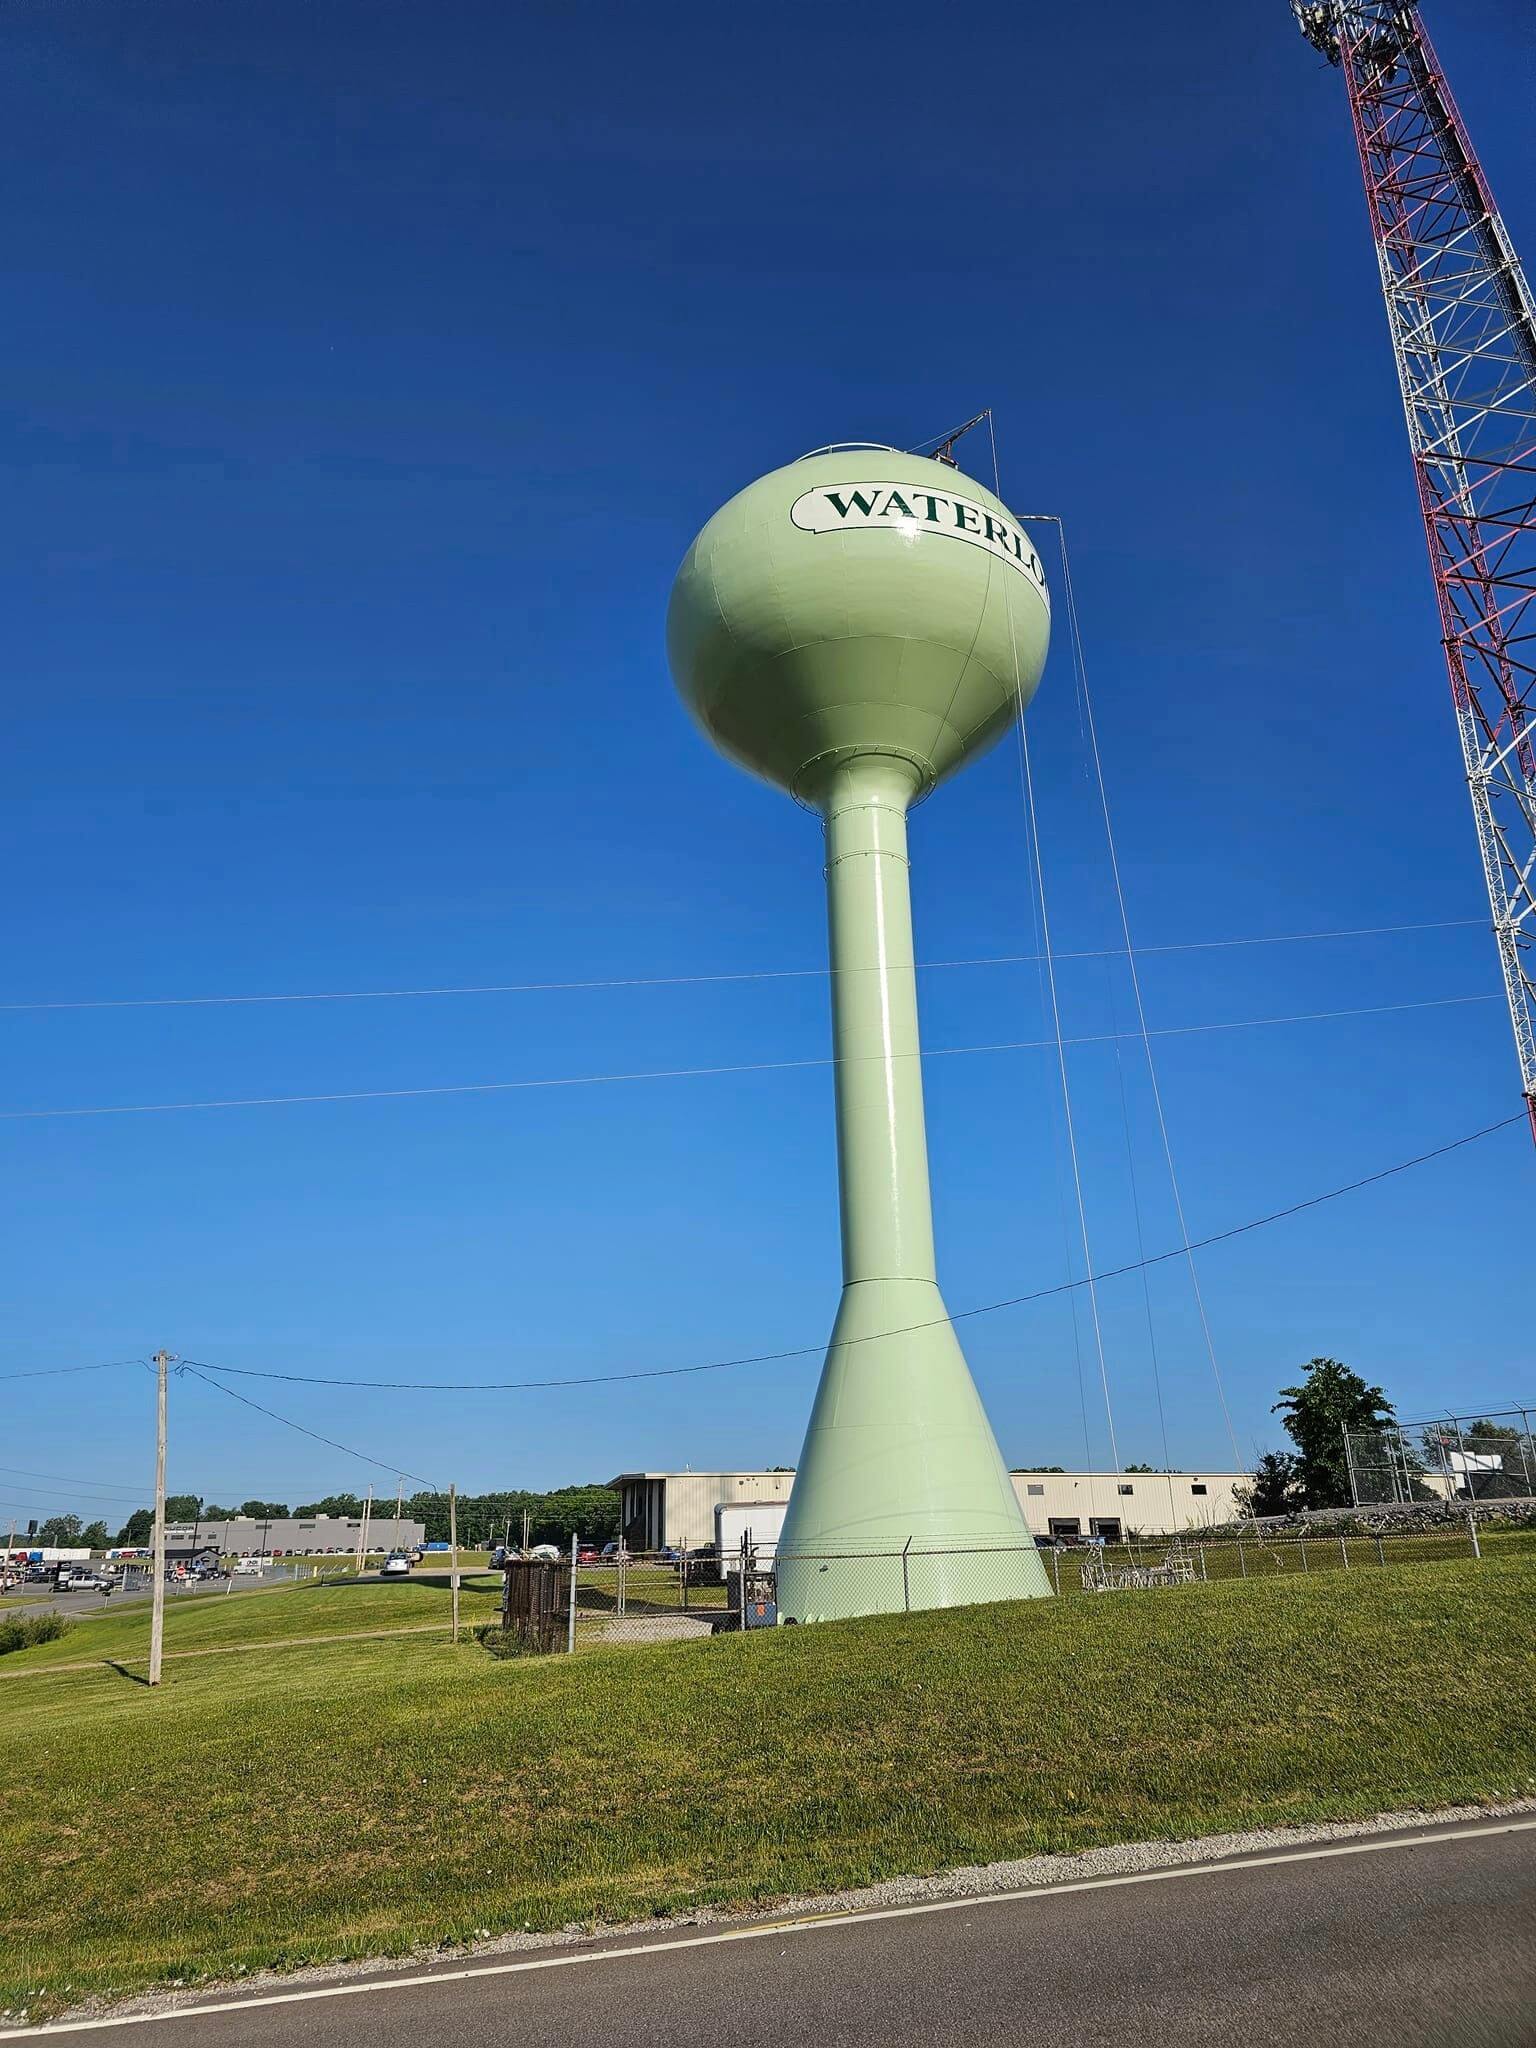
[668,444,1051,805]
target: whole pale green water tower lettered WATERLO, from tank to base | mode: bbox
[668,442,1051,1622]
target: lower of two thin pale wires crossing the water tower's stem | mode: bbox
[0,995,1499,1122]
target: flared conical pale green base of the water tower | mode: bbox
[776,1280,1051,1622]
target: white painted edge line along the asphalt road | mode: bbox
[0,1819,1536,2042]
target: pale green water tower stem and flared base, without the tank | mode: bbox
[778,754,1051,1620]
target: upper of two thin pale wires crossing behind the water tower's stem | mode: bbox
[0,918,1487,1012]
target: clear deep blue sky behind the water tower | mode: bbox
[0,0,1536,1520]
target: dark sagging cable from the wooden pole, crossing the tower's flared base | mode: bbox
[188,1112,1526,1400]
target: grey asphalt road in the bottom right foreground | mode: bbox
[15,1823,1536,2048]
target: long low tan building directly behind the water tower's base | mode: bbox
[608,1473,1251,1550]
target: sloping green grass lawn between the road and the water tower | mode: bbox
[0,1554,1536,2017]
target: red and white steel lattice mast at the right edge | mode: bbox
[1292,0,1536,1137]
